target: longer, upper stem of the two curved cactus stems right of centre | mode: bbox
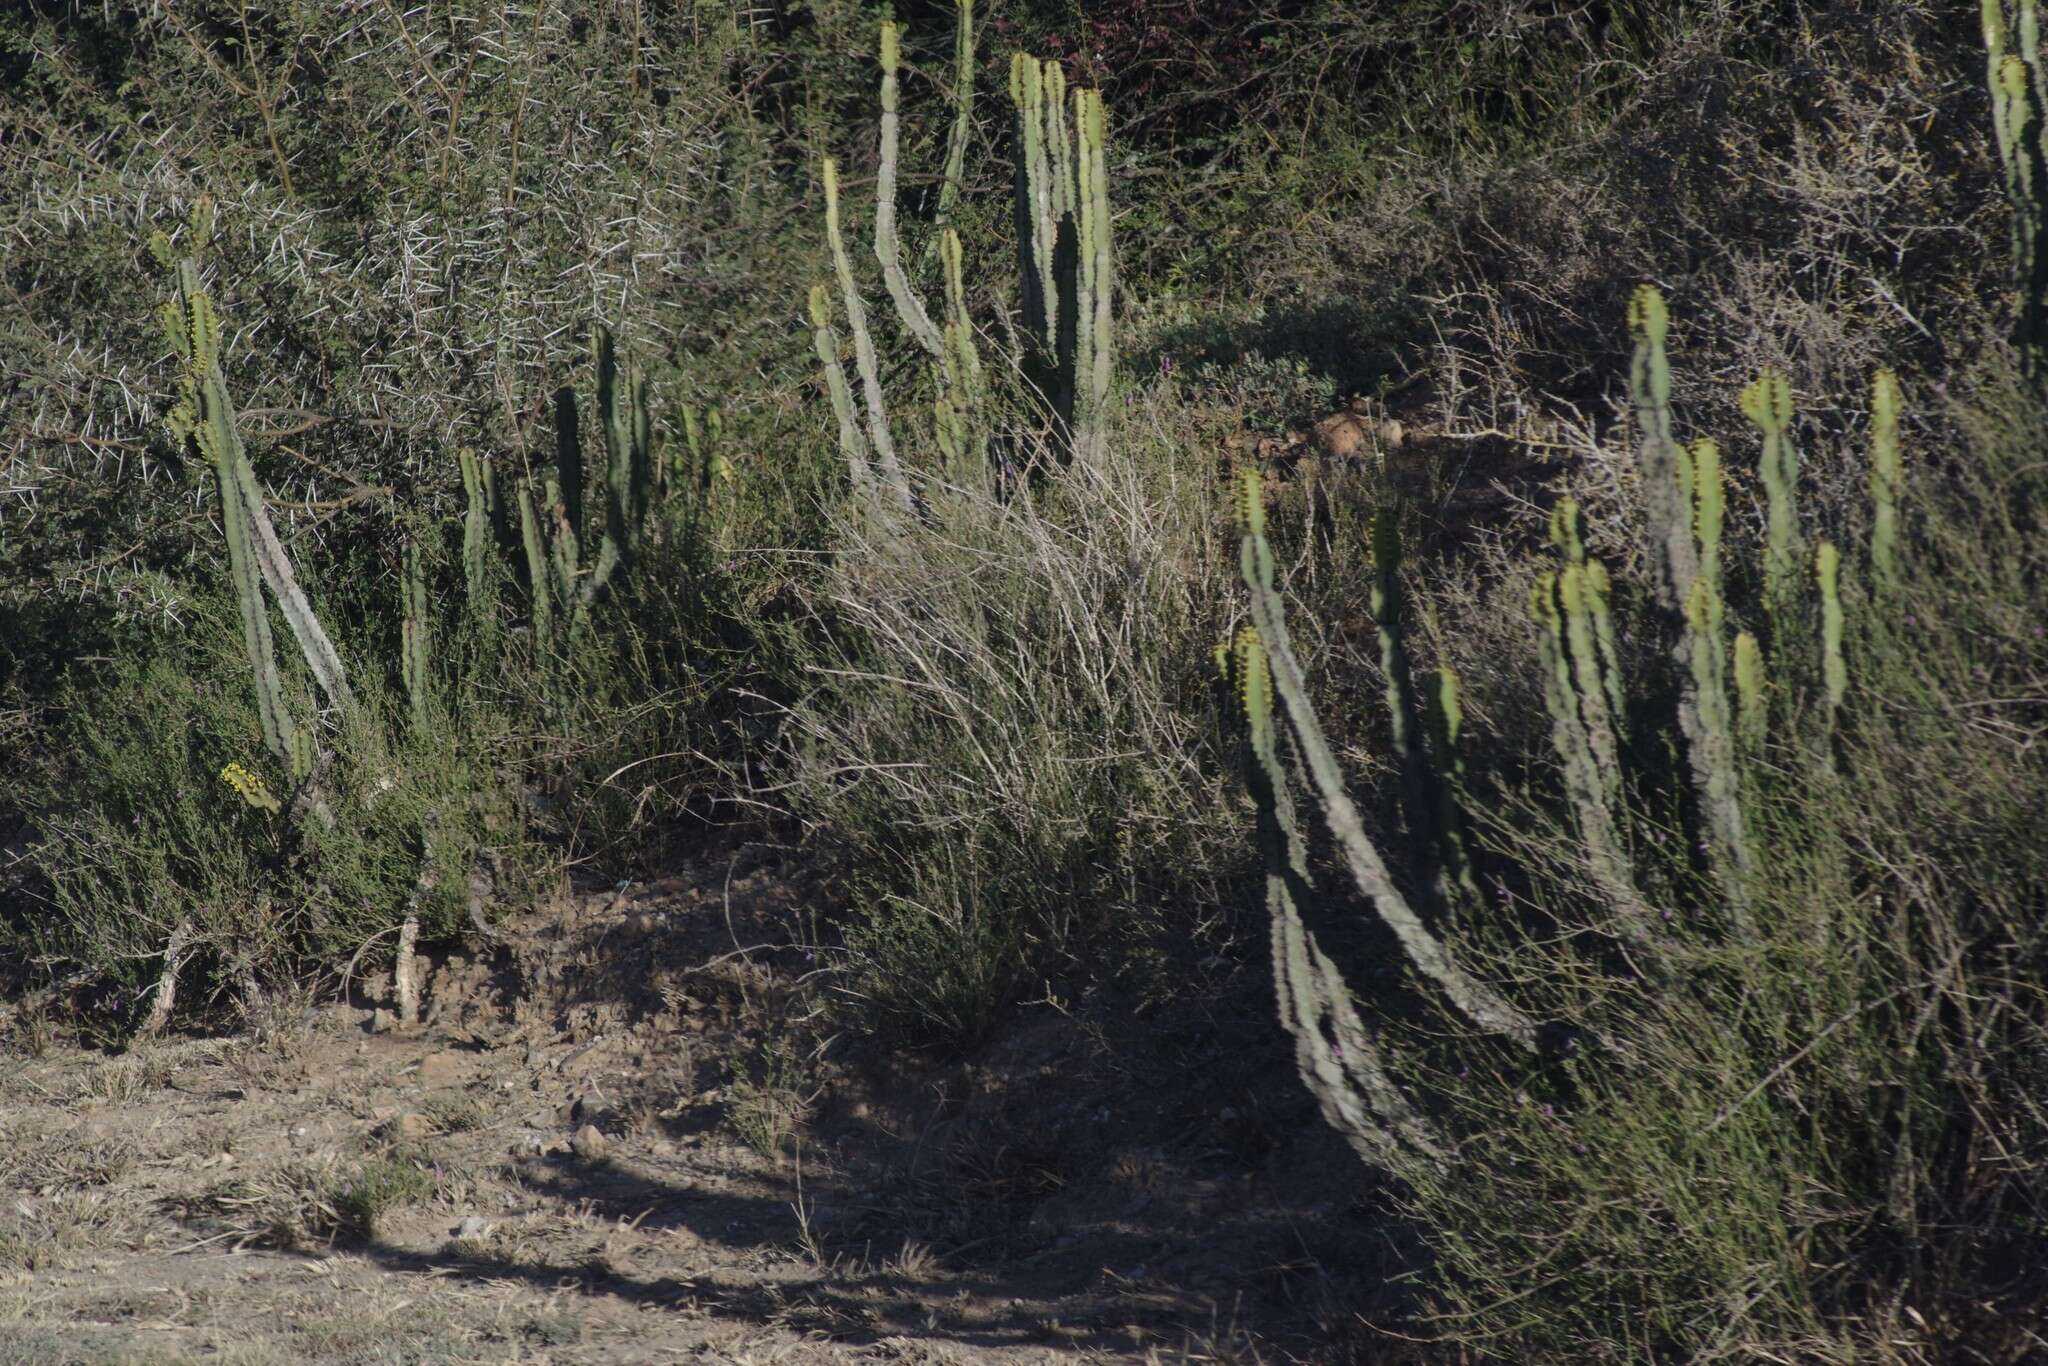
[1239,471,1536,1051]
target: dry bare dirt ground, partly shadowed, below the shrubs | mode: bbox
[0,838,1395,1366]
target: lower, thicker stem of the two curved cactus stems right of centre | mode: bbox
[1231,627,1444,1165]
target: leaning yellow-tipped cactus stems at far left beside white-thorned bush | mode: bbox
[150,197,354,774]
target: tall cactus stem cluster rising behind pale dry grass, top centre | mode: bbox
[809,0,1116,510]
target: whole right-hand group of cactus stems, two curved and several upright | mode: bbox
[1219,287,1905,1167]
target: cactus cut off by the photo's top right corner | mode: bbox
[1980,0,2048,379]
